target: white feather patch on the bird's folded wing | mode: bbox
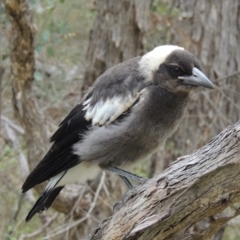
[83,90,143,125]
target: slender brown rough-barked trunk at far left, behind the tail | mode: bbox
[6,0,47,169]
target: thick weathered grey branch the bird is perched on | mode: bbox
[86,122,240,240]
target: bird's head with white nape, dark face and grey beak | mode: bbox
[139,45,214,92]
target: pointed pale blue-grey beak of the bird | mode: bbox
[178,67,214,88]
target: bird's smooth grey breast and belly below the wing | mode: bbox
[78,85,187,167]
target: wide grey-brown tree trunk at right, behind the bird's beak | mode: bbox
[167,0,240,163]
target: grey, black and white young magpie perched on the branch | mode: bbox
[22,45,214,221]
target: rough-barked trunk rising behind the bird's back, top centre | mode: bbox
[83,0,152,94]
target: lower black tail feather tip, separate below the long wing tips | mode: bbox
[26,186,64,222]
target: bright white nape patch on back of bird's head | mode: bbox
[139,45,184,81]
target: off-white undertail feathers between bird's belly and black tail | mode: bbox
[52,162,101,189]
